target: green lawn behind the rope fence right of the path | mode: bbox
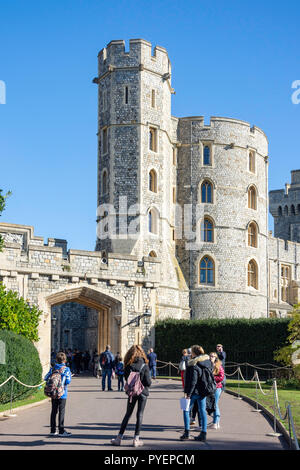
[226,379,300,441]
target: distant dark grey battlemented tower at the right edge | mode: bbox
[269,170,300,243]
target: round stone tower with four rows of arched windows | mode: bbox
[177,117,268,318]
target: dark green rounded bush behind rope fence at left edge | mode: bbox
[0,330,42,404]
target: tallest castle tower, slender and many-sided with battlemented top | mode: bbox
[94,39,176,257]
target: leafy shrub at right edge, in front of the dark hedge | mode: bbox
[274,304,300,380]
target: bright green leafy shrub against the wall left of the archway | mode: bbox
[0,283,42,341]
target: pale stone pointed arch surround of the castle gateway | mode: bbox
[37,286,127,369]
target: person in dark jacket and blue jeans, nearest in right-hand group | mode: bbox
[180,345,215,441]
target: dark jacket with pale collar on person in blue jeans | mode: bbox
[184,354,213,398]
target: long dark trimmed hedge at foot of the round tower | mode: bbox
[155,318,290,364]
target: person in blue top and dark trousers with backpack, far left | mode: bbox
[44,352,72,437]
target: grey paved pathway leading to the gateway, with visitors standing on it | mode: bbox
[0,375,287,451]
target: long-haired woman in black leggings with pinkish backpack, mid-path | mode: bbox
[111,345,151,447]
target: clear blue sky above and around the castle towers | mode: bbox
[0,0,300,250]
